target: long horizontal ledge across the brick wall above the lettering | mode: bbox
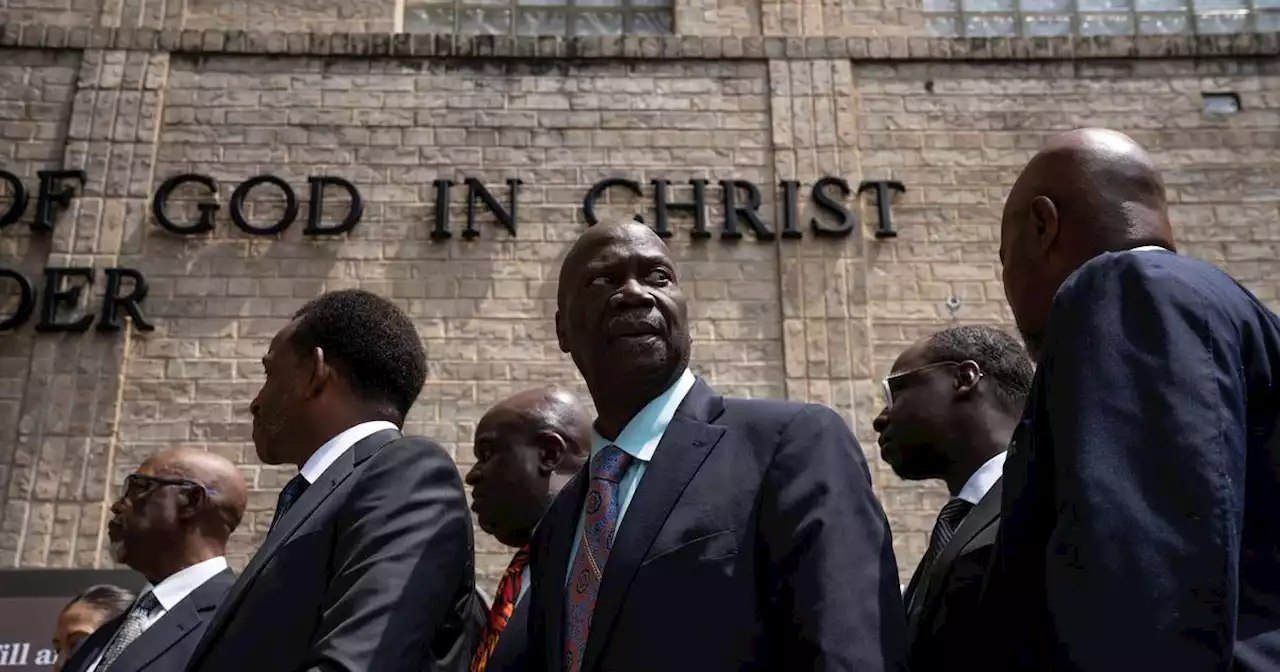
[0,24,1280,61]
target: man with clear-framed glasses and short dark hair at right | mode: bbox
[873,326,1034,672]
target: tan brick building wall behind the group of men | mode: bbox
[0,0,1280,586]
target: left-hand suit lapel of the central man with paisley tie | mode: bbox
[542,462,591,669]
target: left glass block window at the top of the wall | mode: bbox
[404,0,673,37]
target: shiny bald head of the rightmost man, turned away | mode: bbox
[1000,128,1176,356]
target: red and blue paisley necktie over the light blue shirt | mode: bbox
[564,445,631,672]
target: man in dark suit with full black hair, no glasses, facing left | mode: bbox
[191,289,475,672]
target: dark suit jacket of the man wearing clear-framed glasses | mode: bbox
[906,480,1002,672]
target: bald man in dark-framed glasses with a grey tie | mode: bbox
[63,449,248,672]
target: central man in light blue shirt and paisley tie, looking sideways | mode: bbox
[514,221,905,672]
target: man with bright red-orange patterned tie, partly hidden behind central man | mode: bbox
[466,388,591,672]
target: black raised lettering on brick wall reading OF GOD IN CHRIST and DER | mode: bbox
[0,169,906,333]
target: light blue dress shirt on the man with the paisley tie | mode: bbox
[564,369,696,585]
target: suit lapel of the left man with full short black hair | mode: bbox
[192,429,401,660]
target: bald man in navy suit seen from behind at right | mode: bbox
[983,129,1280,671]
